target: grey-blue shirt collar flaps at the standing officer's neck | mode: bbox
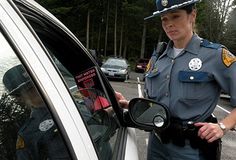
[160,34,202,58]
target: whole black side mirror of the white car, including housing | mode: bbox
[129,98,170,131]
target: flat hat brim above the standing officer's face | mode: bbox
[144,0,199,20]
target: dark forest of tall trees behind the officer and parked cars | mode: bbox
[37,0,236,62]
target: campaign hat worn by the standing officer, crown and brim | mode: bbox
[144,0,200,20]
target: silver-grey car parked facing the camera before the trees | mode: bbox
[101,57,130,81]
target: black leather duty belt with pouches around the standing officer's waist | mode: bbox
[155,116,221,160]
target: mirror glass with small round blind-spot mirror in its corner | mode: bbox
[130,99,167,127]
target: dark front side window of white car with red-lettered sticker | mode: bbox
[15,1,120,160]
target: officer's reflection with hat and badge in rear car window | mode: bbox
[3,65,71,160]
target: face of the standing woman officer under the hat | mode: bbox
[161,9,196,43]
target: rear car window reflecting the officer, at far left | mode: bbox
[0,32,71,160]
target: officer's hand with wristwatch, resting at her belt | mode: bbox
[194,122,224,143]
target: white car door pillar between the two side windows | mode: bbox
[0,0,97,159]
